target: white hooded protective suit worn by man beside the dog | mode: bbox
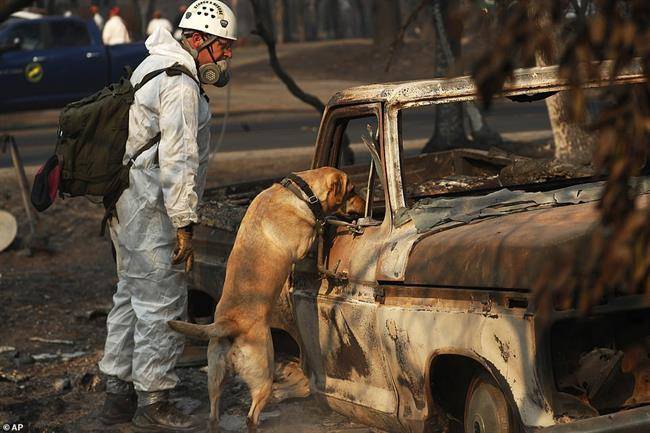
[99,29,211,391]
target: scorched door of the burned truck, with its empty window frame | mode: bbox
[296,104,397,414]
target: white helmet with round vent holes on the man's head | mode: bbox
[178,0,237,41]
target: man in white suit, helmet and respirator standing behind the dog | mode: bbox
[99,0,237,432]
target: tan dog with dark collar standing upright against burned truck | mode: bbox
[169,167,365,432]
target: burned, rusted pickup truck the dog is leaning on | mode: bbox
[185,62,650,433]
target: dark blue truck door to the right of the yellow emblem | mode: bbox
[44,19,108,103]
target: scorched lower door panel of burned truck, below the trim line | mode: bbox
[293,280,397,415]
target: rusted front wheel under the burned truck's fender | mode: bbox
[465,373,517,433]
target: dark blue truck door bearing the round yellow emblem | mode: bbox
[0,20,48,111]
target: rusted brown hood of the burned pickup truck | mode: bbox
[403,182,650,291]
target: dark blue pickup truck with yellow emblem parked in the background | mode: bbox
[0,16,147,113]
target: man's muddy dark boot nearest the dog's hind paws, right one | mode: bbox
[132,391,199,433]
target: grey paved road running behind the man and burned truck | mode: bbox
[0,102,550,168]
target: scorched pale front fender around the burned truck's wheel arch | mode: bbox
[377,296,555,427]
